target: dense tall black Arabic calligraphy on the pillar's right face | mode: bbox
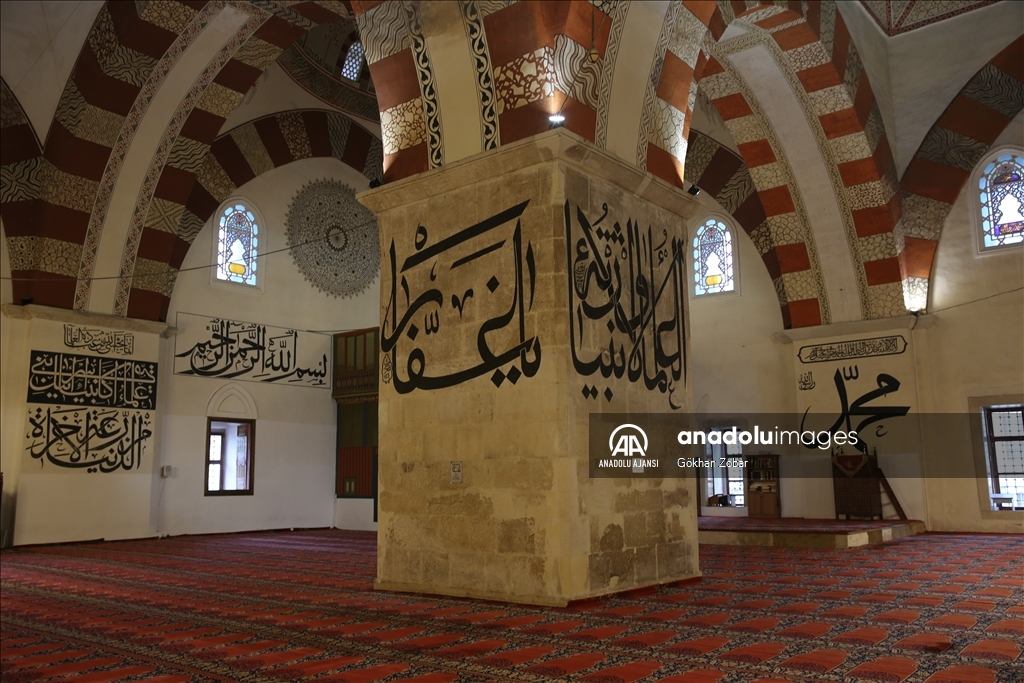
[565,202,686,410]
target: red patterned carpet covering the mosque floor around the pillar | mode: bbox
[0,531,1024,683]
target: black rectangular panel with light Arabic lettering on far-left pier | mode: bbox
[28,351,157,411]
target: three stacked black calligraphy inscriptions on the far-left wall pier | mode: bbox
[25,321,157,473]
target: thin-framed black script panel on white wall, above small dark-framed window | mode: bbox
[174,313,331,388]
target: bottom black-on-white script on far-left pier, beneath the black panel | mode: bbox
[26,407,153,473]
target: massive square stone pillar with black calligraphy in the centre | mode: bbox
[359,129,698,605]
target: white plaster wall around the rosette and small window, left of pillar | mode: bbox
[154,159,380,535]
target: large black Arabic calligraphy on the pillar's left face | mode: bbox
[381,200,541,394]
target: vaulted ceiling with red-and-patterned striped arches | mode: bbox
[0,0,1024,328]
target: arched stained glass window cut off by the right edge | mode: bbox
[978,154,1024,249]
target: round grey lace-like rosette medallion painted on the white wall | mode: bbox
[285,180,381,296]
